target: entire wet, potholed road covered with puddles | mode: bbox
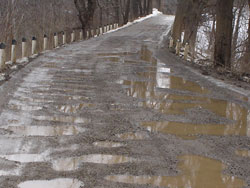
[0,15,250,188]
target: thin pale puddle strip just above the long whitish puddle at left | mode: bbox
[33,116,89,123]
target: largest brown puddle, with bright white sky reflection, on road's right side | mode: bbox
[118,46,250,137]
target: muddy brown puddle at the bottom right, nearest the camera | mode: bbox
[105,155,244,188]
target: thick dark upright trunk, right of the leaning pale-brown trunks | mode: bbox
[214,0,234,68]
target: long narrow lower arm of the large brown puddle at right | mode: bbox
[141,122,246,137]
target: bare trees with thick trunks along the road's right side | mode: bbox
[172,0,250,73]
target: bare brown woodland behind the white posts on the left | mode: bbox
[0,0,153,60]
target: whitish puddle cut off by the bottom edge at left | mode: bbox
[18,178,84,188]
